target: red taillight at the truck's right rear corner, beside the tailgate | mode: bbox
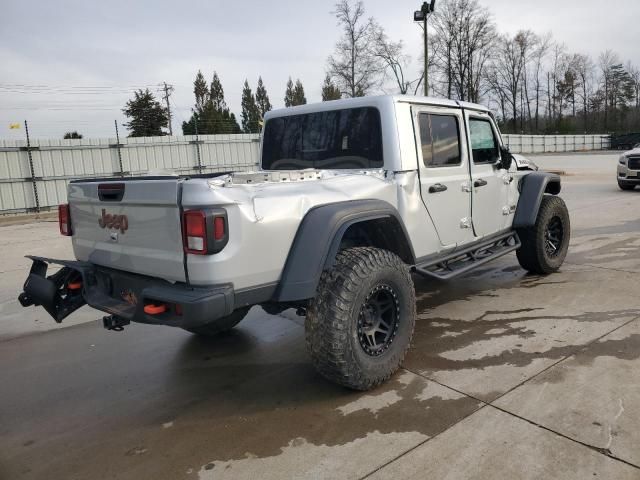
[182,209,229,255]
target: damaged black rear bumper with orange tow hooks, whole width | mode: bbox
[19,257,244,328]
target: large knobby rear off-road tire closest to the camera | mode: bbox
[305,247,416,390]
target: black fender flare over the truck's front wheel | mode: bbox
[513,172,562,228]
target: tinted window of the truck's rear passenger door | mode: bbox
[419,113,461,168]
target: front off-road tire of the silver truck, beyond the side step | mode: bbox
[517,195,571,275]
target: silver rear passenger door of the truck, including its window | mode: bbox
[413,106,473,247]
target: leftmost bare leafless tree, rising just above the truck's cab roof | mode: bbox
[328,0,383,97]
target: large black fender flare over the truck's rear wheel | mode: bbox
[275,200,415,302]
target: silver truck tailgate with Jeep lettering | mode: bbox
[69,177,186,282]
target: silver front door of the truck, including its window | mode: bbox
[467,112,512,237]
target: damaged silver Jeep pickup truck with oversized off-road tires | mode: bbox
[20,96,570,390]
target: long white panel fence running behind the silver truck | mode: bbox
[0,131,610,213]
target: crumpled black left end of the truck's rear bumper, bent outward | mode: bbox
[18,258,86,323]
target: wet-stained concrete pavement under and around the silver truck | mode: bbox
[0,155,640,480]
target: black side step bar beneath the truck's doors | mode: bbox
[414,232,522,280]
